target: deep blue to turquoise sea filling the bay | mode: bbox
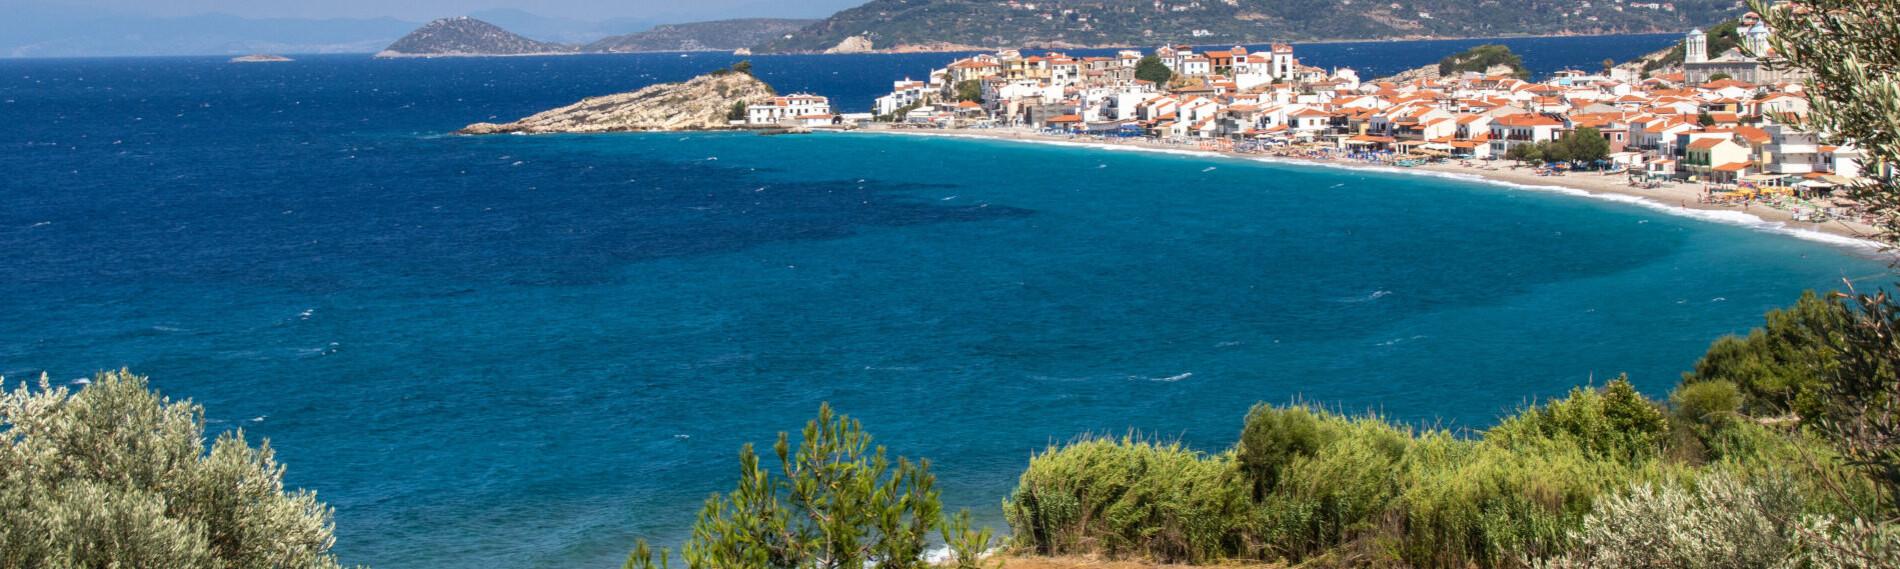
[0,36,1883,567]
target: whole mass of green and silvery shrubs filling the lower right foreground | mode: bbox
[1005,361,1877,567]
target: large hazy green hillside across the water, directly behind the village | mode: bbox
[758,0,1739,51]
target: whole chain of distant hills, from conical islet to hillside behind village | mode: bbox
[378,0,1739,55]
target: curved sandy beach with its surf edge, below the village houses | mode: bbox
[851,128,1892,259]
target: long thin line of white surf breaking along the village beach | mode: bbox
[880,131,1883,253]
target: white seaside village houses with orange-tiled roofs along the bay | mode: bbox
[870,13,1862,192]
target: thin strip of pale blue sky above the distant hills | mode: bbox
[13,0,865,21]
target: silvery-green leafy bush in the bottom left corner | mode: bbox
[0,371,347,569]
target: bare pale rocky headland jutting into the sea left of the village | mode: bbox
[456,63,777,135]
